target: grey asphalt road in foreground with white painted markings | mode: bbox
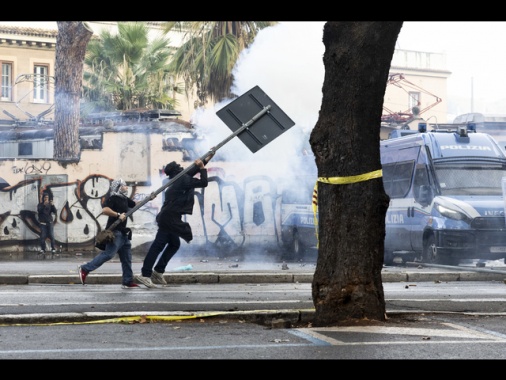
[0,315,506,360]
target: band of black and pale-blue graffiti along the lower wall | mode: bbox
[0,171,288,253]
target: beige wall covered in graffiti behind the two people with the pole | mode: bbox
[0,122,310,255]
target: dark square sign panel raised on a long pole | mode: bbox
[216,86,295,153]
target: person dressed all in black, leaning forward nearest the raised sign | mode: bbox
[135,155,212,288]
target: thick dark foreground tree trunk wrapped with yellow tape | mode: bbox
[310,21,402,326]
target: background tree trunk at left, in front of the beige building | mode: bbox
[53,21,93,162]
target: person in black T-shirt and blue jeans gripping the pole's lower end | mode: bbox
[77,178,155,289]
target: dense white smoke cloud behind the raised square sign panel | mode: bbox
[192,22,325,182]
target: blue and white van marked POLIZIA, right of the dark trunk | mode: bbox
[380,123,506,265]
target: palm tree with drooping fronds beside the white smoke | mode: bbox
[164,21,277,108]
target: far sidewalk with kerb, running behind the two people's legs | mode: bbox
[0,253,506,285]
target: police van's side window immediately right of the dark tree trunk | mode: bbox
[382,160,415,198]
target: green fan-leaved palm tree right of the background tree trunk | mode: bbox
[83,22,183,113]
